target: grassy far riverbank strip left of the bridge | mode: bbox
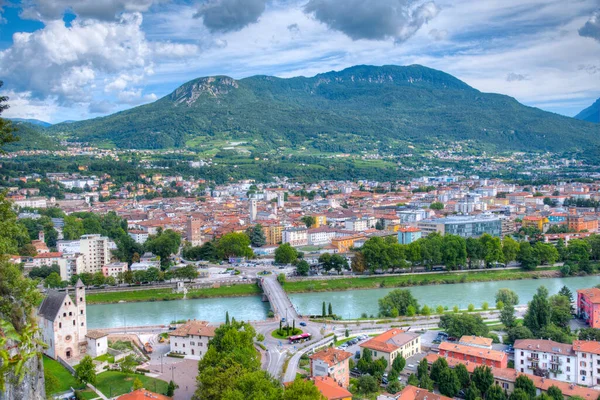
[86,283,262,304]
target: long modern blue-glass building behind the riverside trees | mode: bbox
[417,214,502,238]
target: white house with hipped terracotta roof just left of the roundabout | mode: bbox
[169,319,215,359]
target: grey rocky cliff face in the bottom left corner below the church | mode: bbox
[0,355,46,400]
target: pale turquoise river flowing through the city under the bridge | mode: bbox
[87,276,600,329]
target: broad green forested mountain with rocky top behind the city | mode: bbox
[48,65,600,155]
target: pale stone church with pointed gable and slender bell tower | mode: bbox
[38,279,88,360]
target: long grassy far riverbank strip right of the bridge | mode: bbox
[283,267,558,293]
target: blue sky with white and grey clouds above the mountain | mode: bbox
[0,0,600,123]
